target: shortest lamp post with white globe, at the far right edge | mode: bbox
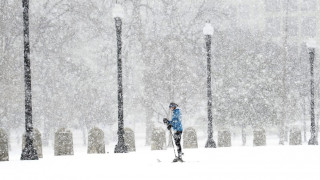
[306,39,318,145]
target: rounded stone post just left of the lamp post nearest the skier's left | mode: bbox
[87,128,106,154]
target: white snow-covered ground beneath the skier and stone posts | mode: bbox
[0,131,320,180]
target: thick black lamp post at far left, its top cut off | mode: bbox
[21,0,39,160]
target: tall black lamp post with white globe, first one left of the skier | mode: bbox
[112,4,127,153]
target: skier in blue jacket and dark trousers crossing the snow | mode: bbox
[163,102,183,162]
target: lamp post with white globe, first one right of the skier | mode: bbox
[203,22,216,148]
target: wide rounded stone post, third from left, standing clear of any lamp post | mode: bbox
[54,128,73,156]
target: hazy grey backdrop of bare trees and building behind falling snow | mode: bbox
[0,0,320,145]
